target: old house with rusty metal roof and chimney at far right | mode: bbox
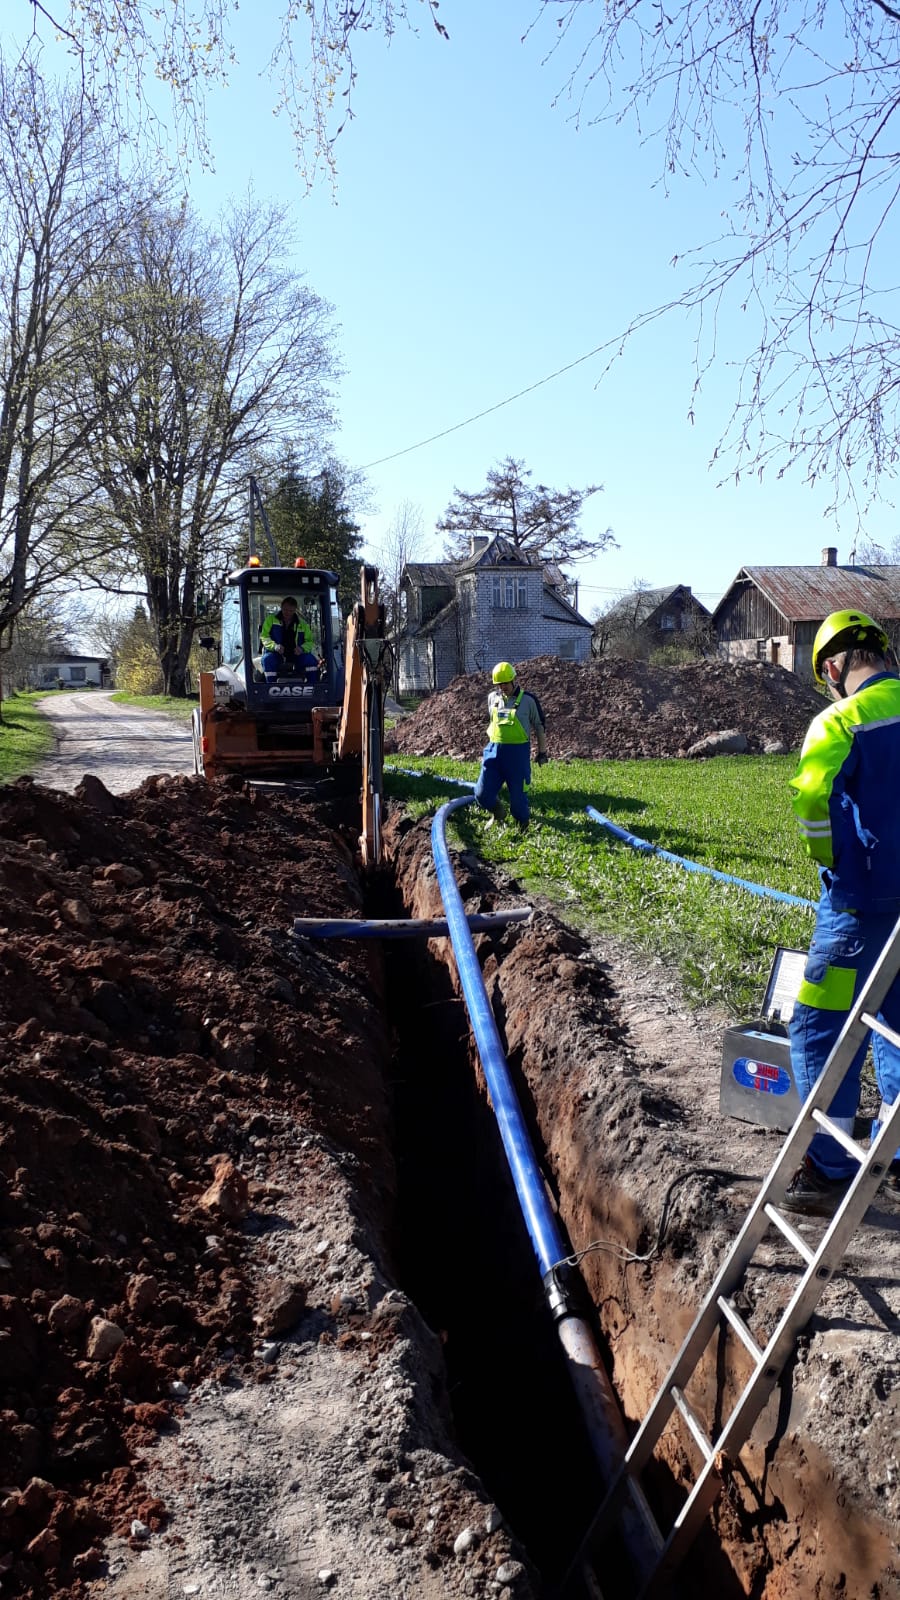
[713,546,900,677]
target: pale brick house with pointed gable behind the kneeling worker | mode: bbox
[397,534,591,694]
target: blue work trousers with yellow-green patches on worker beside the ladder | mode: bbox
[790,882,900,1178]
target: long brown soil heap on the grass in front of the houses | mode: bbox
[386,656,825,760]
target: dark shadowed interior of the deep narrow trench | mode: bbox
[370,888,621,1600]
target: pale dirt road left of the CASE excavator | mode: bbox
[35,690,194,794]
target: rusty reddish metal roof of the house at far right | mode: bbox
[714,565,900,622]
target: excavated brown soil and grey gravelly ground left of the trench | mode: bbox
[0,778,532,1597]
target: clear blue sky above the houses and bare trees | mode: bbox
[14,0,895,611]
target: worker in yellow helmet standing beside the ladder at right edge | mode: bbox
[785,610,900,1216]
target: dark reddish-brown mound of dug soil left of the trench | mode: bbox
[0,778,391,1595]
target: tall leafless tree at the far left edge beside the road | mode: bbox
[0,61,138,720]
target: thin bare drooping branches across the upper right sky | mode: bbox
[533,0,900,501]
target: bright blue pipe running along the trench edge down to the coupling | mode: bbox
[431,795,567,1277]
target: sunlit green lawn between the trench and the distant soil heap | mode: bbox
[381,755,818,1016]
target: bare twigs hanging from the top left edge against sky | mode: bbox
[23,0,448,181]
